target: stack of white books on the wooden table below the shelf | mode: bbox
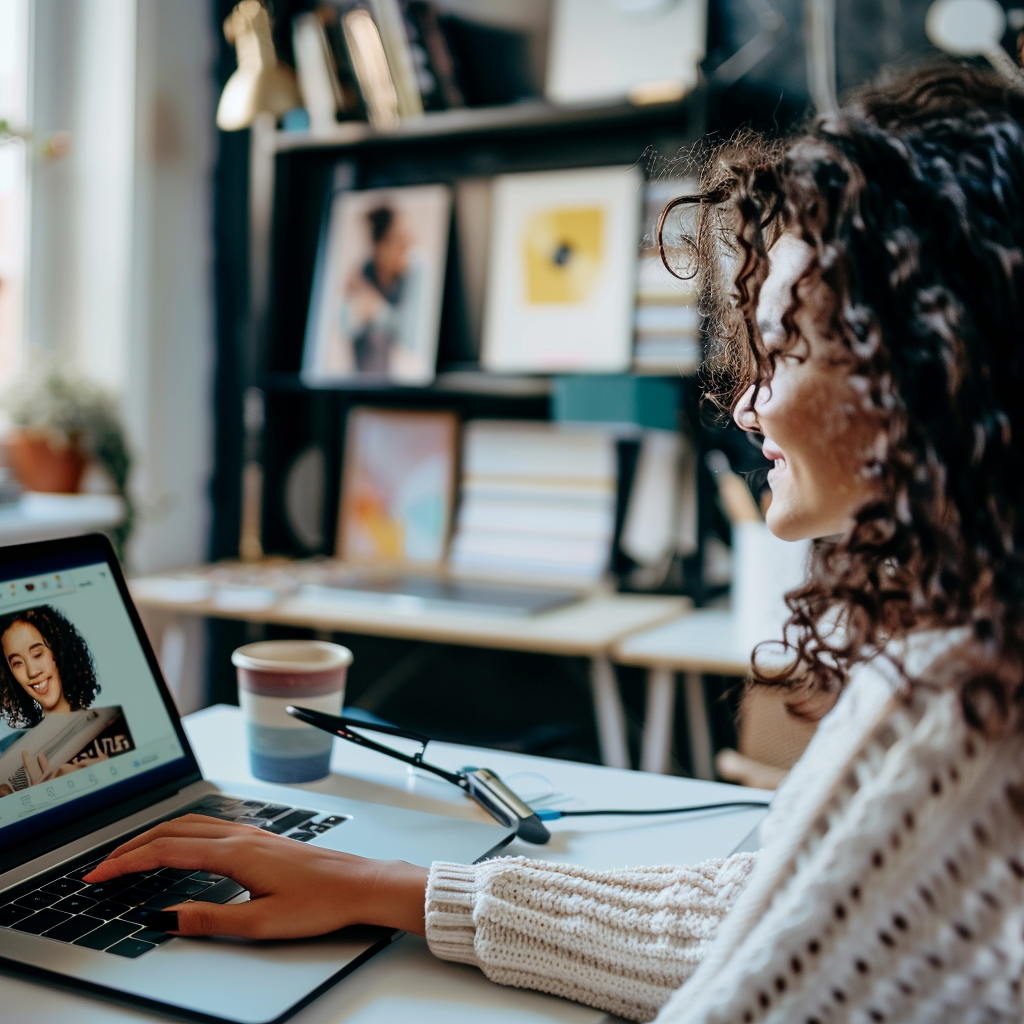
[451,420,617,584]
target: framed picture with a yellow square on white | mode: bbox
[482,167,643,373]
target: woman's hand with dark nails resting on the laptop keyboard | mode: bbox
[85,814,428,939]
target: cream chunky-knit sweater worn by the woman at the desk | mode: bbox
[426,635,1024,1024]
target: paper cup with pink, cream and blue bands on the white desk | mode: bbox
[231,640,352,782]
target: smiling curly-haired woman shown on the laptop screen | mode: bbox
[0,604,103,796]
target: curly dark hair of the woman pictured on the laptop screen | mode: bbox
[0,604,99,729]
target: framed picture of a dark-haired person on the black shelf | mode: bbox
[302,185,452,386]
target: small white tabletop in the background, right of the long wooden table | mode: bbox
[612,609,752,676]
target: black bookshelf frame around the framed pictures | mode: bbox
[232,91,706,557]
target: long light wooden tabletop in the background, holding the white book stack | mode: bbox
[130,575,690,657]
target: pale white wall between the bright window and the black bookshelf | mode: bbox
[27,0,215,707]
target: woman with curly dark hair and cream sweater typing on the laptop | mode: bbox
[83,65,1024,1024]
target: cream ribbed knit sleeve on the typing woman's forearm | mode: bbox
[426,853,756,1021]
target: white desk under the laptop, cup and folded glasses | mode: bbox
[0,707,766,1024]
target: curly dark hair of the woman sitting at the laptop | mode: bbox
[695,61,1024,733]
